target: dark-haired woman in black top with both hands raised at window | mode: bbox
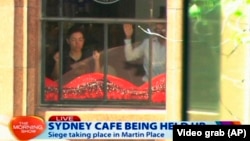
[52,26,100,79]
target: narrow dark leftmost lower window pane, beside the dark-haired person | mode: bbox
[41,22,60,102]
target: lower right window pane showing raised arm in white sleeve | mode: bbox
[103,22,166,104]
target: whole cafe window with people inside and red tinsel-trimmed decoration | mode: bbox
[41,0,166,109]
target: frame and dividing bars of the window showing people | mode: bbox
[39,0,167,109]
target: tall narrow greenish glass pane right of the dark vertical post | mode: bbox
[184,0,221,112]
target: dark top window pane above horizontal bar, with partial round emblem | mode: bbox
[43,0,166,18]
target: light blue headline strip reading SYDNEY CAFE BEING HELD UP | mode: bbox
[36,121,215,140]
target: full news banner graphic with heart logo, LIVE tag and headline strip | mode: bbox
[9,115,250,141]
